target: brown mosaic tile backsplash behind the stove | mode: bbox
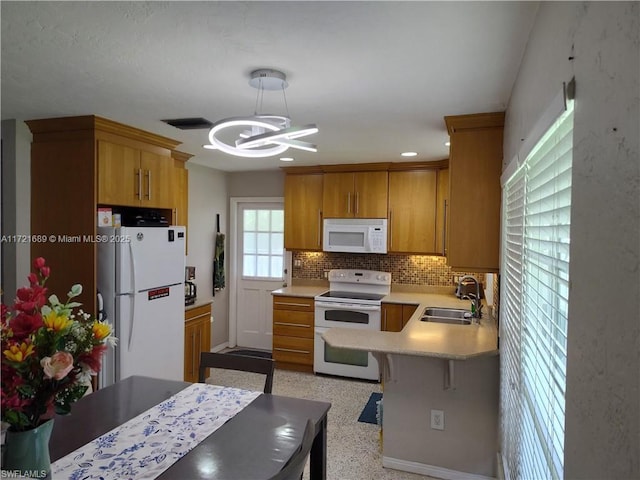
[291,252,486,287]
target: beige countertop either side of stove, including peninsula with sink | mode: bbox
[272,286,498,360]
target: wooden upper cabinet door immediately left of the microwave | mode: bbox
[284,174,323,250]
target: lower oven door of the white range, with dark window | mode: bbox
[313,327,380,382]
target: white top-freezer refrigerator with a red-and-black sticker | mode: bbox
[97,227,185,387]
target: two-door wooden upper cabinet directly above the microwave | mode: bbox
[322,171,389,218]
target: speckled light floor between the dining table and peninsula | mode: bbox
[202,369,438,480]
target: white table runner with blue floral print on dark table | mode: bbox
[51,383,261,480]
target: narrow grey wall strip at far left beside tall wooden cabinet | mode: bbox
[1,120,31,304]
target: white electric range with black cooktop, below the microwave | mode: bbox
[313,269,391,381]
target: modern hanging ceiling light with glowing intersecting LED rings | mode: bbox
[203,69,318,158]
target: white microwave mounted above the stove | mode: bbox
[322,218,387,253]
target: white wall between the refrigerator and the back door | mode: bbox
[187,162,229,347]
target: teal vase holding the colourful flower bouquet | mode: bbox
[2,419,53,478]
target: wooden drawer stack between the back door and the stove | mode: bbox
[273,295,314,372]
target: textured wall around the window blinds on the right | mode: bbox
[505,2,640,479]
